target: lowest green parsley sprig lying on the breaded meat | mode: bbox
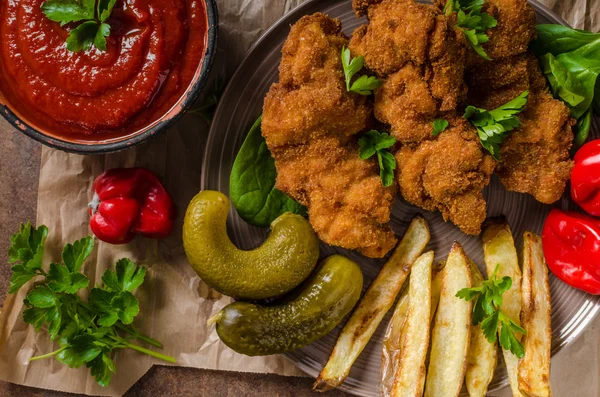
[358,130,396,187]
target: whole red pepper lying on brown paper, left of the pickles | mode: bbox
[89,168,176,244]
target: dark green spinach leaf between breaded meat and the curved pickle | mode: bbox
[229,116,307,227]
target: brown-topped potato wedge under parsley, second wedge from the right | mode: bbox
[483,220,523,397]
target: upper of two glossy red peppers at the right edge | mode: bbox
[571,139,600,216]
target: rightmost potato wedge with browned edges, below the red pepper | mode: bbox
[518,233,552,397]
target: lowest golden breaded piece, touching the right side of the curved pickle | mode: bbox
[273,137,396,258]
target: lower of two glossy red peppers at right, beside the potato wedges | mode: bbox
[542,209,600,295]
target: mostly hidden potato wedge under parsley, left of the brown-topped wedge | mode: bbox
[465,260,498,397]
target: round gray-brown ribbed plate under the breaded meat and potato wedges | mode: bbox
[202,0,600,396]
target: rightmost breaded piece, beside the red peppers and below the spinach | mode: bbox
[467,52,575,204]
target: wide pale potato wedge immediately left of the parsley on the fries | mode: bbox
[425,243,473,397]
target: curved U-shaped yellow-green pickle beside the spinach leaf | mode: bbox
[183,190,319,300]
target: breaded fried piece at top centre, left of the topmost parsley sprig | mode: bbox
[349,0,466,112]
